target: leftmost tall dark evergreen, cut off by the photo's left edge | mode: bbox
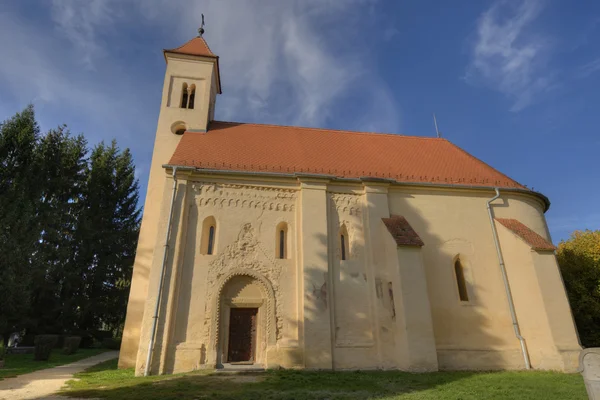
[0,106,39,335]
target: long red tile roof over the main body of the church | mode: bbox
[169,121,525,189]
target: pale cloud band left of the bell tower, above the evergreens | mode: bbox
[0,5,160,184]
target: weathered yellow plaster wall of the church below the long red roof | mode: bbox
[125,172,578,373]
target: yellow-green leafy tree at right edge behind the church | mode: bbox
[557,230,600,347]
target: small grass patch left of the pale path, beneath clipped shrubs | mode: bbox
[0,349,107,380]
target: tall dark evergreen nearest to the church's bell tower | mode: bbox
[77,141,141,329]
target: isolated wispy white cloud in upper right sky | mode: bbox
[466,0,554,111]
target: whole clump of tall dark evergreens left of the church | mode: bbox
[0,106,141,335]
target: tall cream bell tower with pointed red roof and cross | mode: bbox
[119,28,221,368]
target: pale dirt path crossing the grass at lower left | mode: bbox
[0,351,119,400]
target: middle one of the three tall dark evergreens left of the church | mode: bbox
[32,126,87,333]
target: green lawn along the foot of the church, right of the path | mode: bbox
[62,360,587,400]
